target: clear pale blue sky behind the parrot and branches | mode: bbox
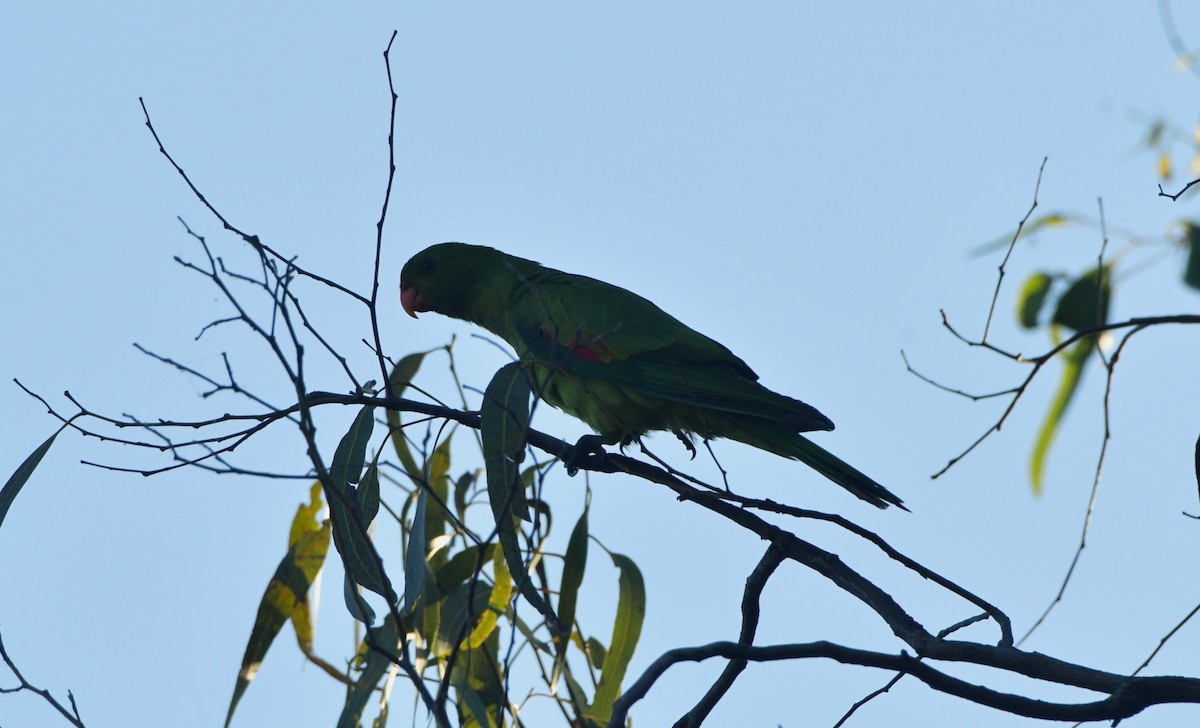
[0,1,1200,727]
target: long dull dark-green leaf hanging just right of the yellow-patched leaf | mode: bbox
[325,407,396,604]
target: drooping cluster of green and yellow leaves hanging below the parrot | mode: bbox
[218,354,646,727]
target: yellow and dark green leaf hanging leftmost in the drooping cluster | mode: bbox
[224,485,330,726]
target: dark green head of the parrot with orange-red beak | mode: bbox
[400,242,505,321]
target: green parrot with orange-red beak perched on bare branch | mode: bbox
[400,242,907,510]
